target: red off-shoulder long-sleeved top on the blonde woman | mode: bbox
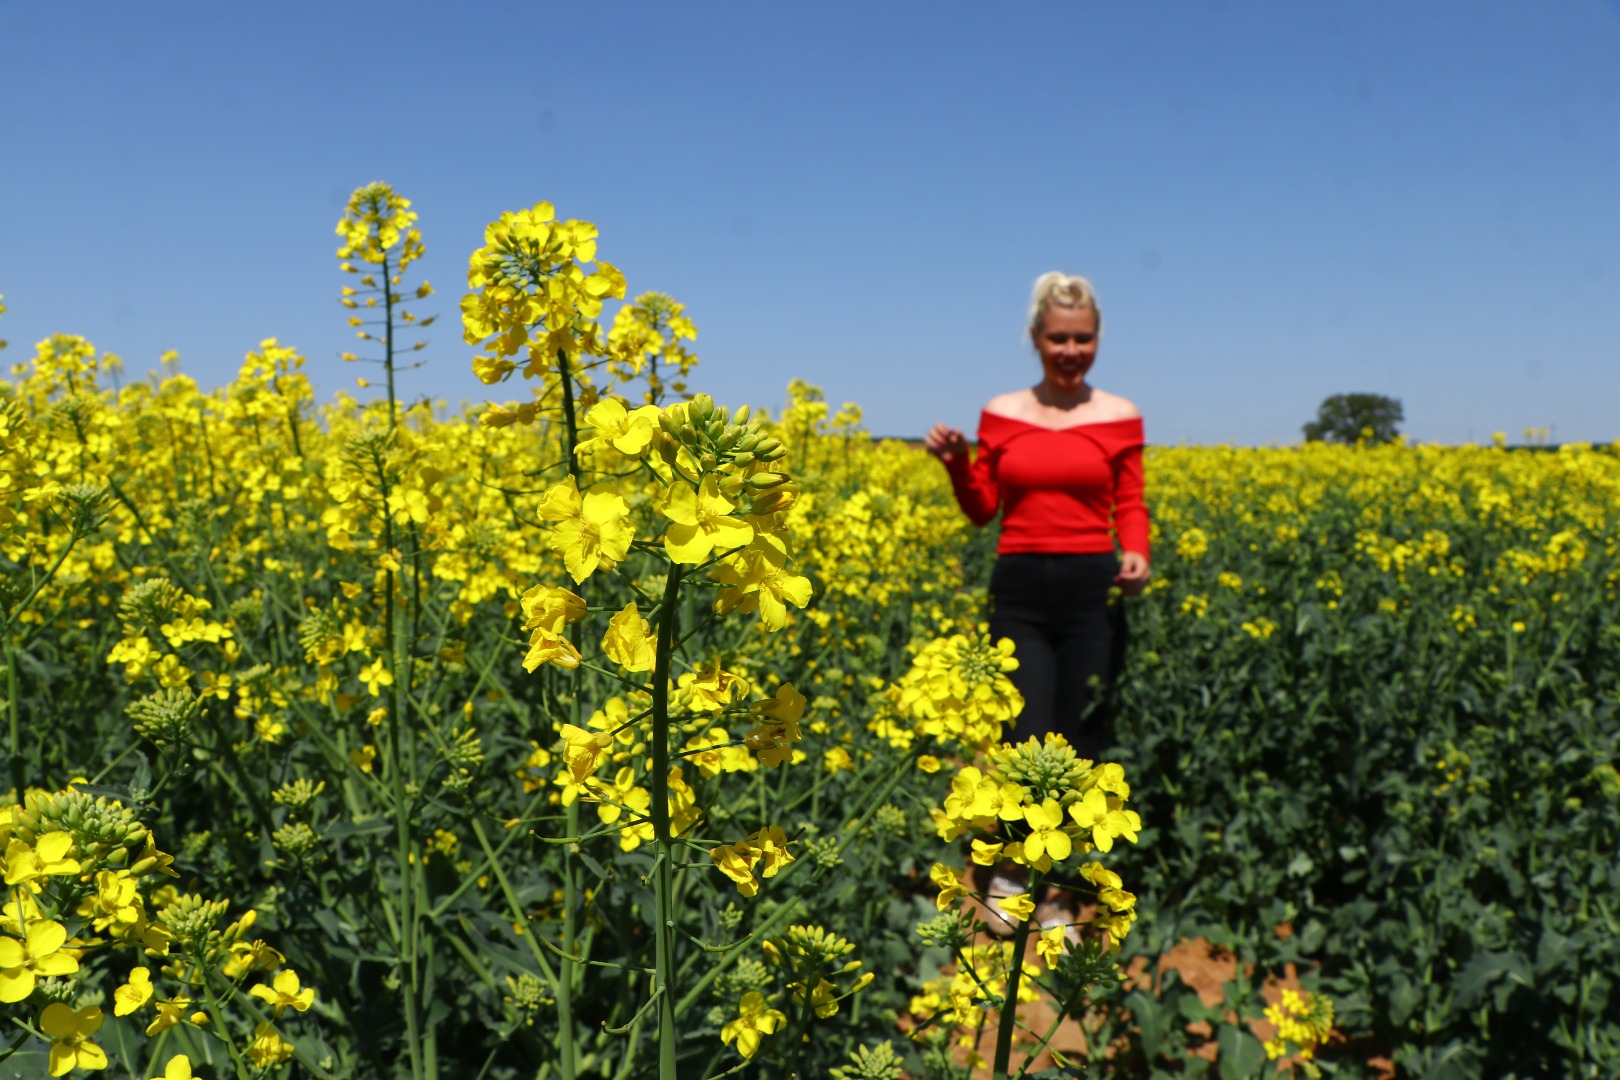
[946,411,1149,555]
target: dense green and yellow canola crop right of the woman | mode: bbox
[1113,449,1620,1077]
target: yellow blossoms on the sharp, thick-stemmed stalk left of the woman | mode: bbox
[498,395,810,874]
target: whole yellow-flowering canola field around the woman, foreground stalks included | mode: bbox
[0,185,1620,1080]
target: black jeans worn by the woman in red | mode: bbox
[990,554,1126,761]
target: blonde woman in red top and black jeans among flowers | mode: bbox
[925,272,1150,761]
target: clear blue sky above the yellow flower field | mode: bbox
[0,0,1620,444]
